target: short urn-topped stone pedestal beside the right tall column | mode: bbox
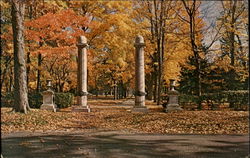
[165,79,183,112]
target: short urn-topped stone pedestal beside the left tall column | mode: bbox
[40,79,56,112]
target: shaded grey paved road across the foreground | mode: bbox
[1,131,249,158]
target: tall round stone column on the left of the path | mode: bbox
[73,36,90,112]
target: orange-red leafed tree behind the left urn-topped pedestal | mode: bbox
[26,10,87,91]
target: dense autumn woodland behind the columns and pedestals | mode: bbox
[0,0,249,113]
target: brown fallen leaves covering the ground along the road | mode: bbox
[1,101,249,134]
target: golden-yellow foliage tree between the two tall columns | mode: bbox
[68,1,135,99]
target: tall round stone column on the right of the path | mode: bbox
[132,35,148,112]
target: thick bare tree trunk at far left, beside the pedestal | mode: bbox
[11,0,29,113]
